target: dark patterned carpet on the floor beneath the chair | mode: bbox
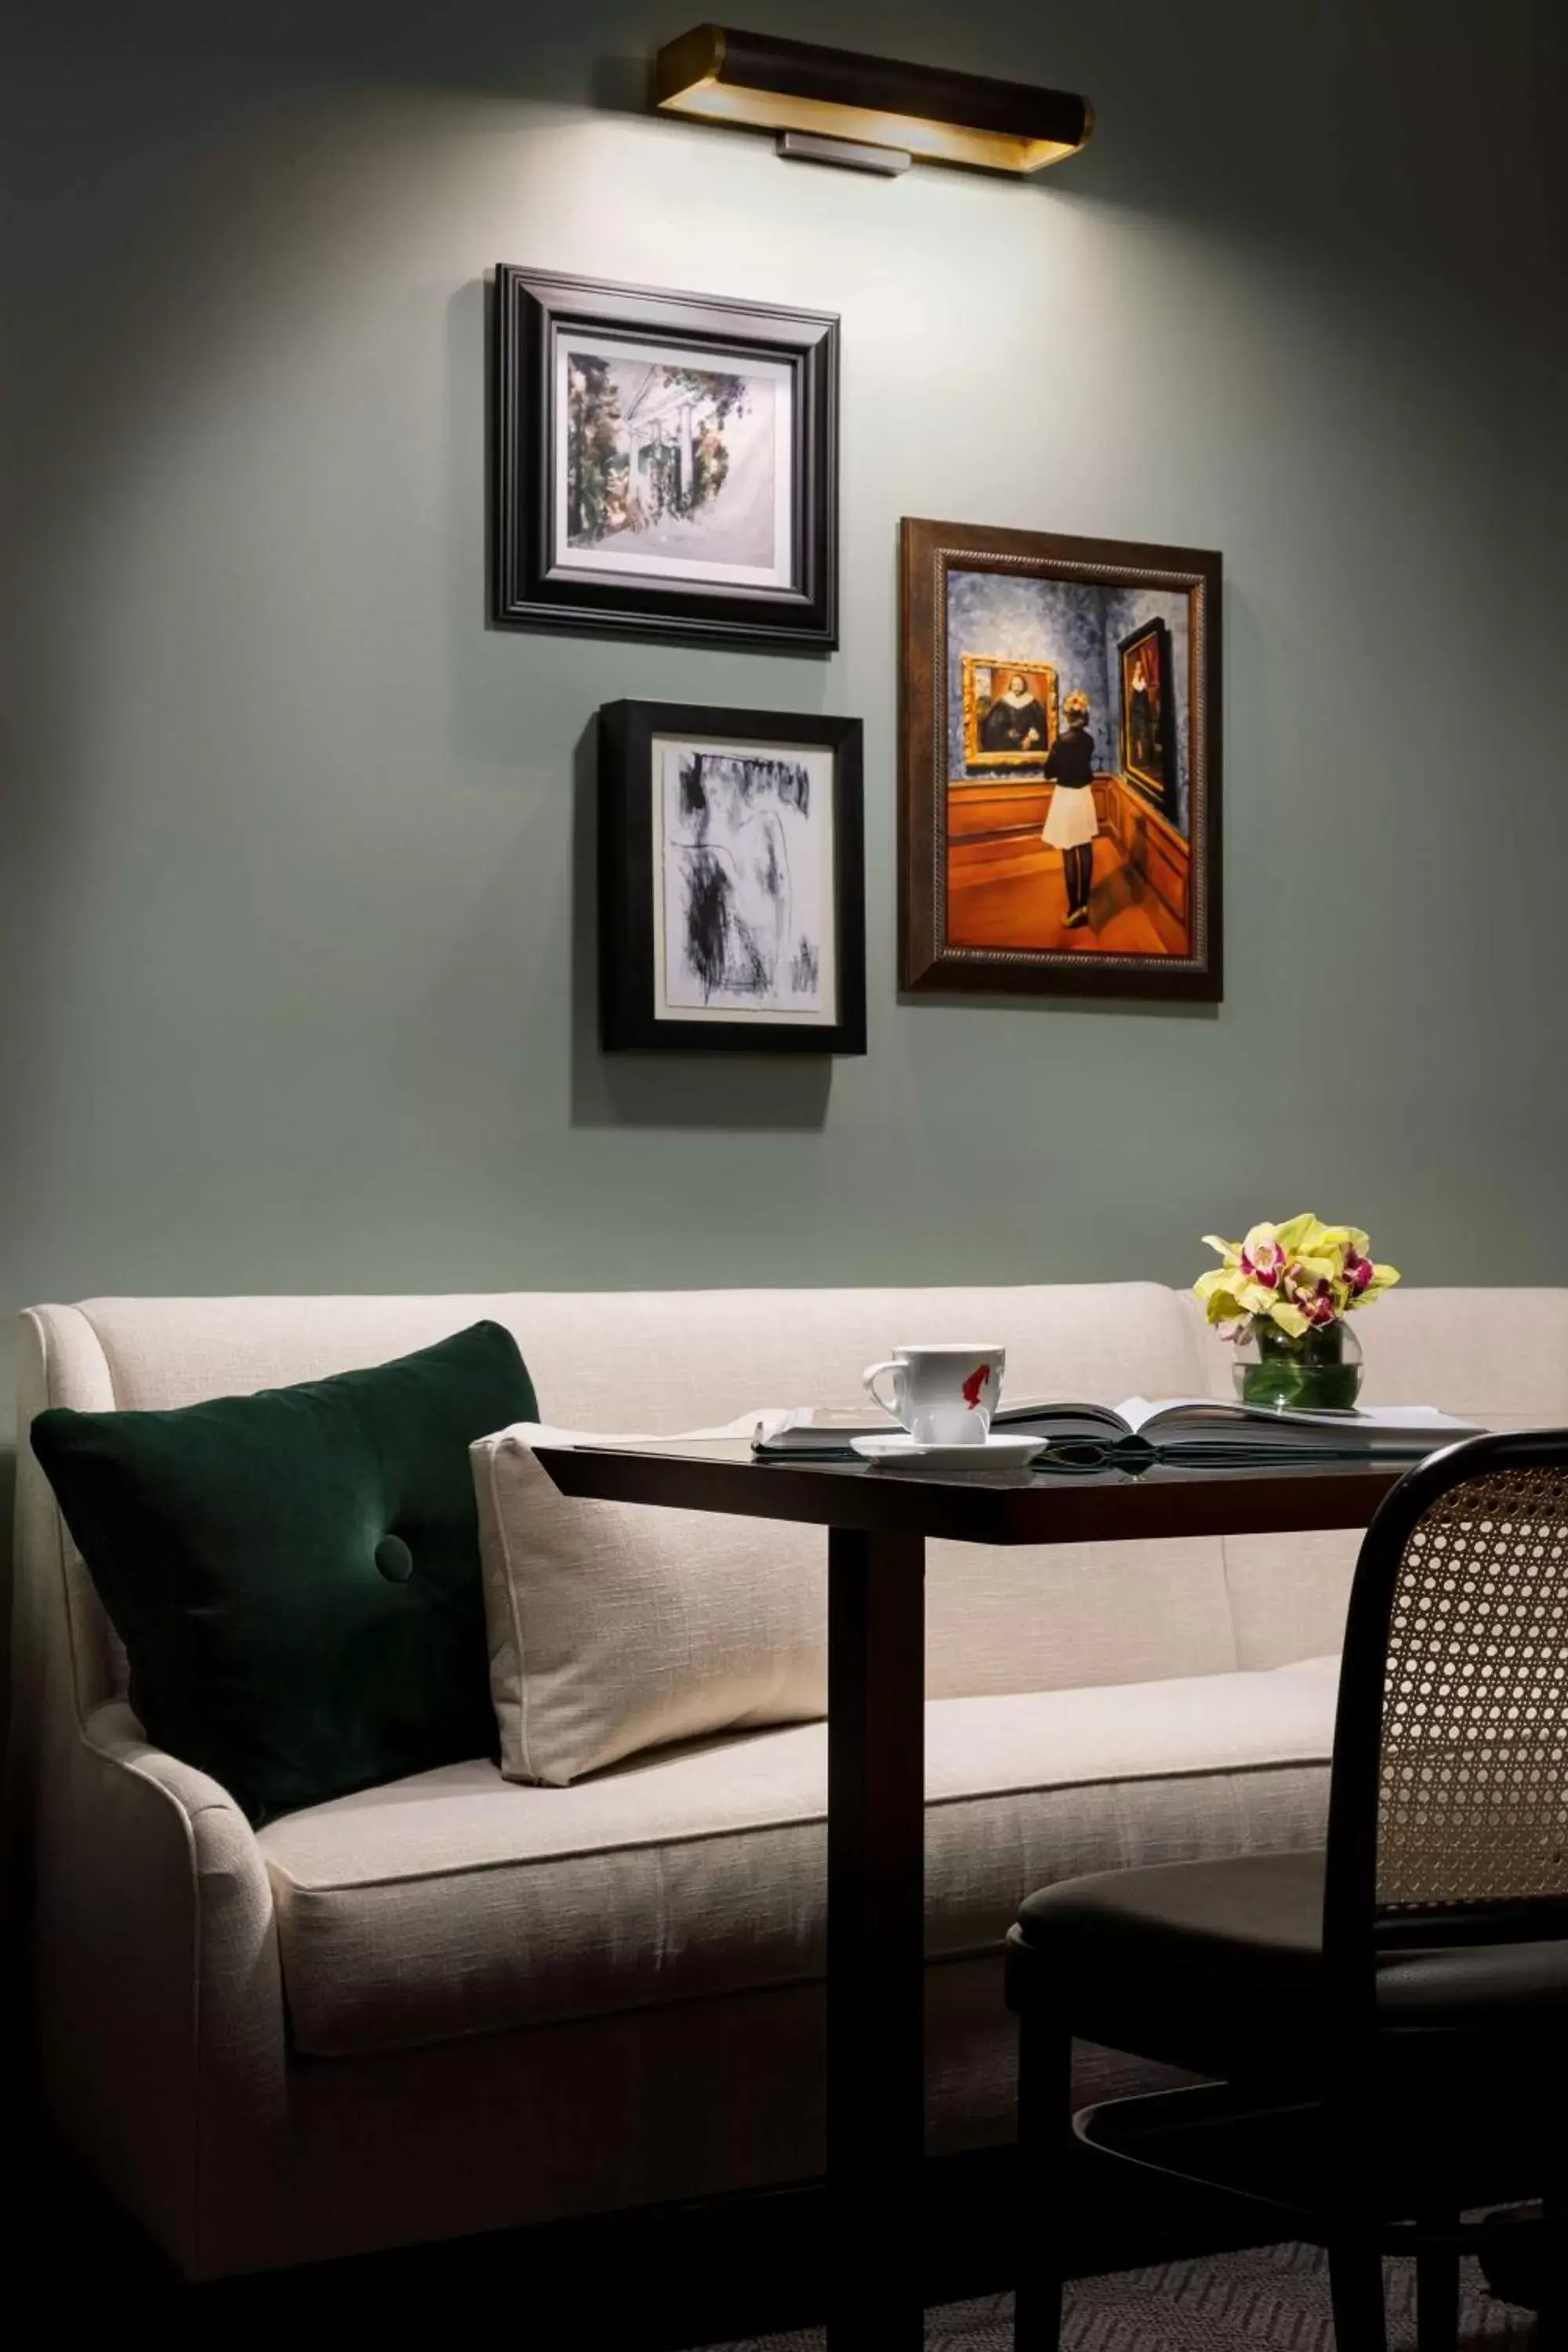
[722,2246,1535,2352]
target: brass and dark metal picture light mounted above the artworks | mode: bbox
[656,24,1093,174]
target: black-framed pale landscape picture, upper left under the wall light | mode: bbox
[494,266,839,654]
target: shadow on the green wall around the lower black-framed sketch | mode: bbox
[572,717,832,1131]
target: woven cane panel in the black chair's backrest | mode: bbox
[1377,1470,1568,1907]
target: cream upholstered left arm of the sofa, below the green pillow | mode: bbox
[38,1703,287,2277]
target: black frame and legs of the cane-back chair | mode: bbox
[1008,1430,1568,2352]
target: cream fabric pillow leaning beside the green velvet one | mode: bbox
[470,1423,827,1788]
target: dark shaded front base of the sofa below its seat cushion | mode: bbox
[251,1955,1168,2267]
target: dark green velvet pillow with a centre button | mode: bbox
[33,1322,539,1825]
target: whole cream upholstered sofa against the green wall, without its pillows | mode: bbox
[14,1284,1568,2277]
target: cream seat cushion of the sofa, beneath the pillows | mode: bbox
[259,1658,1338,2058]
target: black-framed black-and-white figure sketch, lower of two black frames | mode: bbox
[600,703,865,1054]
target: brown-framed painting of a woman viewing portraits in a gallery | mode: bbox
[898,520,1222,1002]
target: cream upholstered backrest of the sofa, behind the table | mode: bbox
[54,1289,1568,1703]
